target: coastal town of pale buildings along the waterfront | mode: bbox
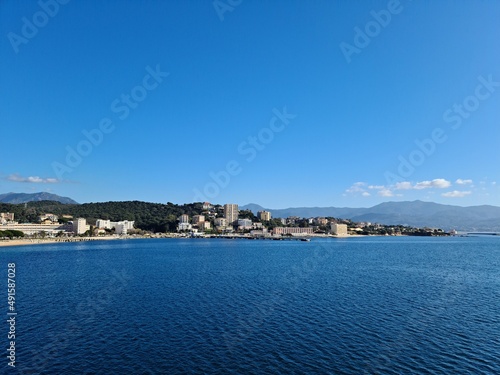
[0,202,453,241]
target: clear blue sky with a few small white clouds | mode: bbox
[0,0,500,208]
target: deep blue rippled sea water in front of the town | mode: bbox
[0,237,500,374]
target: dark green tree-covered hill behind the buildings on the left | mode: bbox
[0,201,203,232]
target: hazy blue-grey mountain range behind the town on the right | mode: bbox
[241,200,500,232]
